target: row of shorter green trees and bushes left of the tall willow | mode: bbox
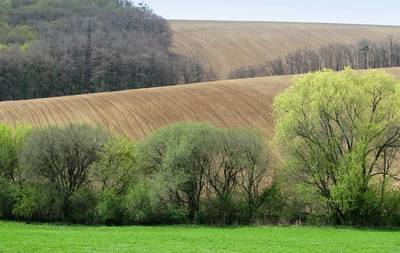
[0,123,278,225]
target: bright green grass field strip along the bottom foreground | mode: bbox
[0,222,400,253]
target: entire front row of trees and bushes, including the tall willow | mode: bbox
[0,69,400,227]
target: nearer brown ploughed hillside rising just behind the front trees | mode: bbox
[0,68,400,139]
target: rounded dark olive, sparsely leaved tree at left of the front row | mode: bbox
[21,125,109,219]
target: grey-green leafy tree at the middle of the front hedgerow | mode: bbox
[138,124,216,221]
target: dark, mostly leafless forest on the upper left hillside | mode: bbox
[0,0,210,100]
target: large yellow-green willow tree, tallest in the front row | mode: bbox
[275,69,400,223]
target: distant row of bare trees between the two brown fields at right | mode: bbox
[231,37,400,78]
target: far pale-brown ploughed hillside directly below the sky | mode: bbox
[170,21,400,80]
